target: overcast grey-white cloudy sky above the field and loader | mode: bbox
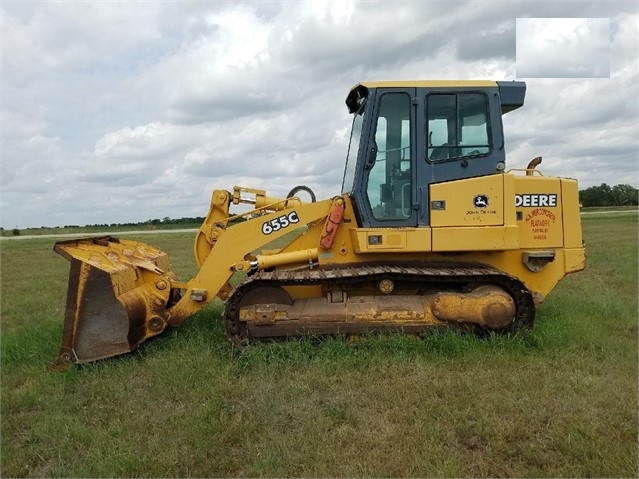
[0,0,639,229]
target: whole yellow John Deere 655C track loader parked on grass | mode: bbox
[53,81,585,366]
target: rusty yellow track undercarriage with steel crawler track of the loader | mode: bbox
[224,263,535,346]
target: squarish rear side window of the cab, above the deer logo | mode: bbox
[426,93,491,161]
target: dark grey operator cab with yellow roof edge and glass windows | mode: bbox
[342,81,526,227]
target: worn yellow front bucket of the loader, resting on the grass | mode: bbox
[50,236,176,369]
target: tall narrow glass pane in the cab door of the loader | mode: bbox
[366,93,412,220]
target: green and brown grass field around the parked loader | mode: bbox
[0,213,639,477]
